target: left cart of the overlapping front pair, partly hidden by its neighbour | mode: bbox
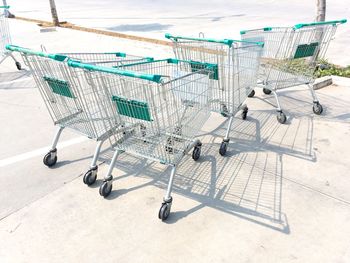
[6,45,150,185]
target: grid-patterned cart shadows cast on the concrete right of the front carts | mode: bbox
[95,108,317,234]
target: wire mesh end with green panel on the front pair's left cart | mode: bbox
[22,53,120,144]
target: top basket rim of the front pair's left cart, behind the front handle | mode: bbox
[58,52,153,67]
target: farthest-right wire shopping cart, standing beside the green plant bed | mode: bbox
[241,19,346,123]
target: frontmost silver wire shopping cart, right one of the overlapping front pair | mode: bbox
[68,59,212,220]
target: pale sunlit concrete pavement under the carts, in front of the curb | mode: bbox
[0,20,350,263]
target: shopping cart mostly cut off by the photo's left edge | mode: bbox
[0,6,22,70]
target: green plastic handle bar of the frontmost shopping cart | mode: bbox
[68,59,163,83]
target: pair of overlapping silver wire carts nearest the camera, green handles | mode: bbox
[7,46,213,220]
